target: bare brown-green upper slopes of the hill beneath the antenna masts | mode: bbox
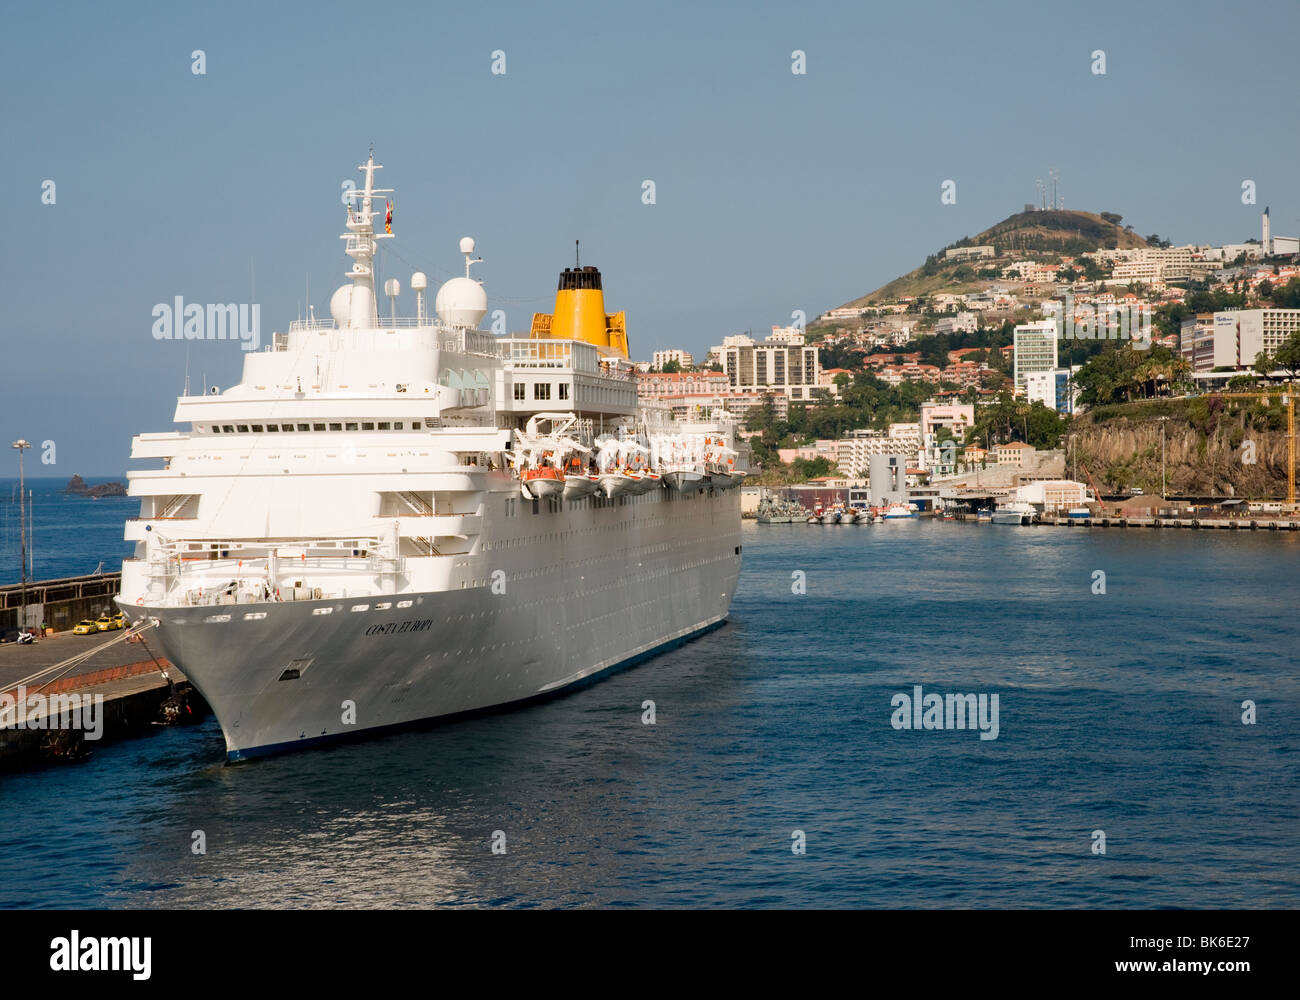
[841,209,1147,308]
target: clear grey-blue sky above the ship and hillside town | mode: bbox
[0,3,1300,477]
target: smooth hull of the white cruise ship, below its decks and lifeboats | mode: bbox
[130,490,741,761]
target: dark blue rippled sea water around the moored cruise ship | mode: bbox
[0,509,1300,908]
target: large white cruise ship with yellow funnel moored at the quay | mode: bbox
[117,152,744,761]
